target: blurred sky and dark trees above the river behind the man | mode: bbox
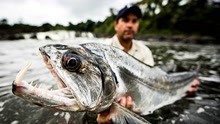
[0,0,220,44]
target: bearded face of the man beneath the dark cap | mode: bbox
[115,14,139,41]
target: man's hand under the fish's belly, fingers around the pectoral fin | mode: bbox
[97,96,133,124]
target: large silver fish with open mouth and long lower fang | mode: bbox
[12,43,198,123]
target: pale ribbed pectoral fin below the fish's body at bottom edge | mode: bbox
[111,103,150,124]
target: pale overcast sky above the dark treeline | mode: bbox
[0,0,140,26]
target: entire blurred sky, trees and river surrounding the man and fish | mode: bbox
[0,0,220,124]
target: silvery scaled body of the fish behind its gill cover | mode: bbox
[82,44,198,115]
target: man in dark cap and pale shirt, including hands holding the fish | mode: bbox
[97,6,199,123]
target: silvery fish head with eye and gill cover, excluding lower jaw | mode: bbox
[39,44,116,109]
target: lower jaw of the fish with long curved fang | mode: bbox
[12,64,85,111]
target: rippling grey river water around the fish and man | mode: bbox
[0,38,220,124]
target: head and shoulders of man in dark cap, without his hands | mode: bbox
[107,6,154,66]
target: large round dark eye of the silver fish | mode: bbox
[61,53,82,72]
